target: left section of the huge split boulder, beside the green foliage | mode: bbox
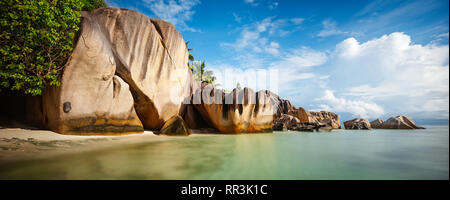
[25,8,152,135]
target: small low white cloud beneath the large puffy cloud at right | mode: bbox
[317,90,384,118]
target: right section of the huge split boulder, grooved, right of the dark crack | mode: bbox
[85,7,193,130]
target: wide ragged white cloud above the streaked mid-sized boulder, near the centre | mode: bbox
[208,46,327,93]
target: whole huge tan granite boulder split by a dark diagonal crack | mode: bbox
[26,7,197,134]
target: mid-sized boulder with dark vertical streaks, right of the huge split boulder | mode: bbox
[191,84,274,133]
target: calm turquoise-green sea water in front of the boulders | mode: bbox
[0,126,449,179]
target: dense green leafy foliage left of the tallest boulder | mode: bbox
[0,0,104,95]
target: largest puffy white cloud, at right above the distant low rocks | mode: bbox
[322,32,449,118]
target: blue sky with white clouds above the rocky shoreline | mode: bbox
[107,0,449,123]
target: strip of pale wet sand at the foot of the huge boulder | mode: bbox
[0,127,214,163]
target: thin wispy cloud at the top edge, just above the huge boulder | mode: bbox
[143,0,200,32]
